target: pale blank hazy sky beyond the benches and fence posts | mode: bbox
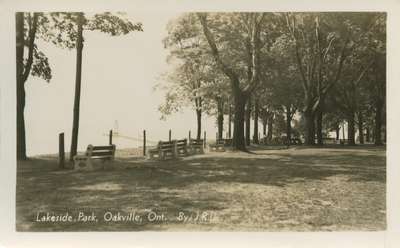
[25,12,241,155]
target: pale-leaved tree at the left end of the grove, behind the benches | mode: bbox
[162,15,209,139]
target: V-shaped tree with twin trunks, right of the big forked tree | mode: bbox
[283,13,371,145]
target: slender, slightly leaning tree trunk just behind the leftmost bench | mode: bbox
[69,13,84,161]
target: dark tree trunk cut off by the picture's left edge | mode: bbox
[15,12,27,160]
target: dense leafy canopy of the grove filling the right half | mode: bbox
[160,12,386,146]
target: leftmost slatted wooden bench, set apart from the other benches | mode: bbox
[74,145,116,170]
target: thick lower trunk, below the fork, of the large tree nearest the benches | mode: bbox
[232,90,247,151]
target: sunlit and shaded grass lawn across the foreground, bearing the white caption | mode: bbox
[16,146,386,231]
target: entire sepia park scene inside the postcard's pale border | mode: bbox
[10,11,387,232]
